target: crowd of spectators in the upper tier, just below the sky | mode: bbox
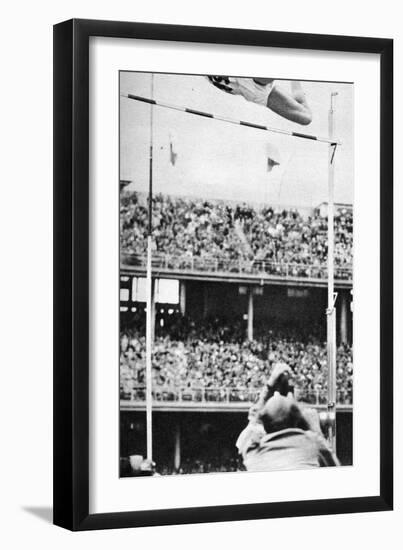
[120,191,353,278]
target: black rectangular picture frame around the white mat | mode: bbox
[53,19,393,531]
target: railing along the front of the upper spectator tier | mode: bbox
[121,253,352,280]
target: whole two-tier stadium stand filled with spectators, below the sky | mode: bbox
[120,190,353,475]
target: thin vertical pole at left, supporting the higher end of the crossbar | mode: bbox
[146,74,154,460]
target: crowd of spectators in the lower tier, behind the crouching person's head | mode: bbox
[120,317,353,404]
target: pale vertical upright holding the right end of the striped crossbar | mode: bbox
[326,92,337,452]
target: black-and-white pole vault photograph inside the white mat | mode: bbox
[116,70,354,478]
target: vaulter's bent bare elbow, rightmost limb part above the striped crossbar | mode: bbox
[267,81,312,126]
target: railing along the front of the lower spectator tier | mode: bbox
[120,385,353,406]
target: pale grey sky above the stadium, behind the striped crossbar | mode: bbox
[120,72,354,207]
